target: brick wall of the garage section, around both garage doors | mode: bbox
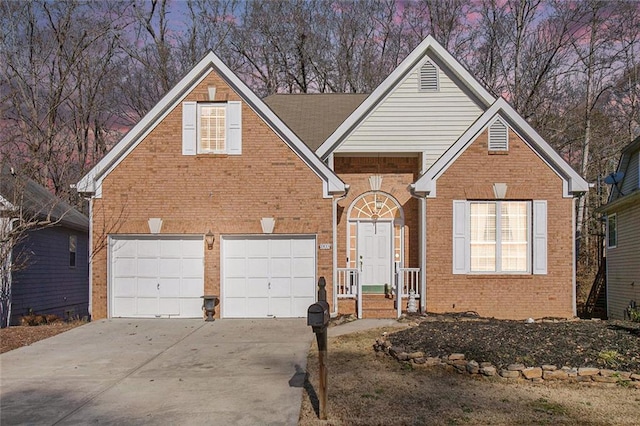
[92,72,332,319]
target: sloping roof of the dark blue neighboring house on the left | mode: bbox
[0,165,89,231]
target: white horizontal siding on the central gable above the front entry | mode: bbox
[335,58,483,170]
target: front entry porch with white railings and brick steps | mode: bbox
[335,267,422,319]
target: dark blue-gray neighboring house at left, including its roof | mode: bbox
[0,167,89,326]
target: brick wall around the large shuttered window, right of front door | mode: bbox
[426,131,574,319]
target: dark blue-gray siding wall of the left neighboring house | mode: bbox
[11,226,89,324]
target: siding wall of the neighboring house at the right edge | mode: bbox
[607,204,640,319]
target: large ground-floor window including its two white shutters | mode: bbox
[453,201,547,274]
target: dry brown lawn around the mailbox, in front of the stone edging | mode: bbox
[299,322,640,426]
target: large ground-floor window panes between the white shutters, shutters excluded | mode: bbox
[469,201,531,273]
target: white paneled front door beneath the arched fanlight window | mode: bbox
[358,222,393,286]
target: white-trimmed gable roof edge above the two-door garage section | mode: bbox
[76,52,346,197]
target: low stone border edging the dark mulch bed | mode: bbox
[373,333,640,389]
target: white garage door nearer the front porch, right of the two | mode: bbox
[221,236,316,318]
